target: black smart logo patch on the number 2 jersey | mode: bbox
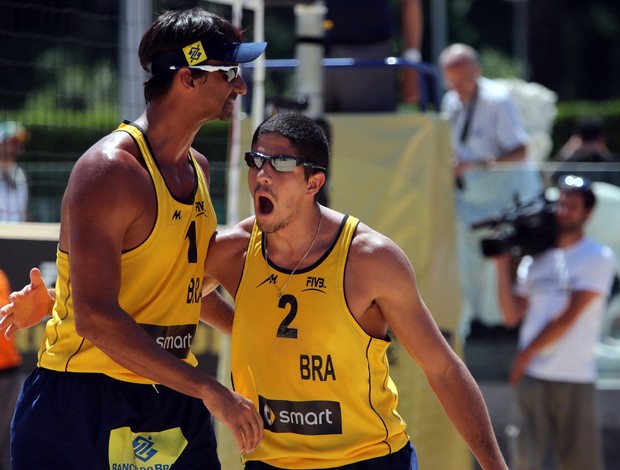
[258,395,342,436]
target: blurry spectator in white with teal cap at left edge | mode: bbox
[0,121,28,222]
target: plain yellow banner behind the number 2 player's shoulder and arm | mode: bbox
[329,114,472,470]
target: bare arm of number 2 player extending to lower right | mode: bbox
[347,229,507,470]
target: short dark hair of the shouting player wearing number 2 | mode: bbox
[252,113,329,177]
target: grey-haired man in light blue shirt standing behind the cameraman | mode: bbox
[439,44,543,336]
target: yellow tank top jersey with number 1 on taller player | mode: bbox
[38,123,217,383]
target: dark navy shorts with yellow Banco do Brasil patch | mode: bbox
[11,368,220,470]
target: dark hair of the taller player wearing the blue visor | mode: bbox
[138,8,241,103]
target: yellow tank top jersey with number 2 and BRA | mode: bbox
[232,217,409,469]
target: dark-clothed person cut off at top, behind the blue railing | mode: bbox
[324,0,422,112]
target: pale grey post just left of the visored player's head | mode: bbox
[119,0,153,123]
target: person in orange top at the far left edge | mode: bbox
[0,269,22,470]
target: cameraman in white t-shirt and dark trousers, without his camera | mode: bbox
[494,175,615,470]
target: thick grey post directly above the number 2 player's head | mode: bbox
[295,1,327,119]
